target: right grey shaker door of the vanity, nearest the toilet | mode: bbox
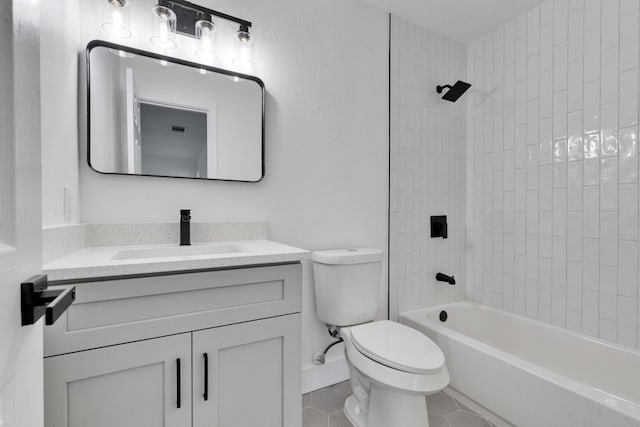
[193,314,301,427]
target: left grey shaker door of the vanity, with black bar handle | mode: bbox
[44,333,191,427]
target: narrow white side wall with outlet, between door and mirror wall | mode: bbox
[40,0,84,226]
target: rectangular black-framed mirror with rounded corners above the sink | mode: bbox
[87,42,264,182]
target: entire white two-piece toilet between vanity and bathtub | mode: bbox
[312,249,449,427]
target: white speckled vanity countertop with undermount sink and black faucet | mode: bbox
[43,240,309,281]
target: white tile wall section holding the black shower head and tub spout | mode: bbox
[389,16,468,318]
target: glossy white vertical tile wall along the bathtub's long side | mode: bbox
[464,0,640,347]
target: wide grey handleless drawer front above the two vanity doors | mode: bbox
[44,264,302,357]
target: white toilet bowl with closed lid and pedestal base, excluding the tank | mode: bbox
[340,320,449,427]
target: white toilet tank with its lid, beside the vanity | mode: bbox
[311,248,382,326]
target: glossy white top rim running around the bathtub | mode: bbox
[399,300,640,421]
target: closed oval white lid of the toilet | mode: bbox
[350,320,444,374]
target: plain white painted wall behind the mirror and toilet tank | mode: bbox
[74,0,388,387]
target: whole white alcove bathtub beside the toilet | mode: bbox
[400,301,640,427]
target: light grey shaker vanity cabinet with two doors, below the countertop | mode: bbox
[44,263,302,427]
